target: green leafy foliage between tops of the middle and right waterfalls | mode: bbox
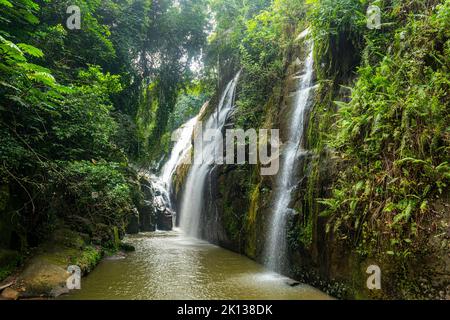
[227,0,305,128]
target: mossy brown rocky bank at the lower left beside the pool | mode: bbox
[0,228,134,300]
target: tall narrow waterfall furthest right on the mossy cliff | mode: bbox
[264,40,314,272]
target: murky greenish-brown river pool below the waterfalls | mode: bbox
[62,230,329,300]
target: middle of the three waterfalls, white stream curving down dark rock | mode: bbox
[179,72,240,238]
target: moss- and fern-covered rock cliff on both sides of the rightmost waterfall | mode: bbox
[174,0,450,299]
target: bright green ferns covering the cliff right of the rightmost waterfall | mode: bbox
[313,0,450,258]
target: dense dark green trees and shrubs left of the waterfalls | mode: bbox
[0,0,207,278]
